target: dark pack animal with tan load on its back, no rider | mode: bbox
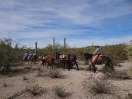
[56,53,79,70]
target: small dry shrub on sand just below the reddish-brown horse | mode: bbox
[49,69,62,78]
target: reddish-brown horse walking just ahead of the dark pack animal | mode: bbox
[39,55,55,69]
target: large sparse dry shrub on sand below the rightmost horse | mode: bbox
[82,75,113,94]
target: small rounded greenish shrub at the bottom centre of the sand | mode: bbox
[53,85,66,97]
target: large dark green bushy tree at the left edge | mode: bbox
[0,37,25,73]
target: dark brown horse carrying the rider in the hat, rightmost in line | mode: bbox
[84,53,113,73]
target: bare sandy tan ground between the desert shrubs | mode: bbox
[0,61,132,99]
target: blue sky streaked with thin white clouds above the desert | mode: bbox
[0,0,132,48]
